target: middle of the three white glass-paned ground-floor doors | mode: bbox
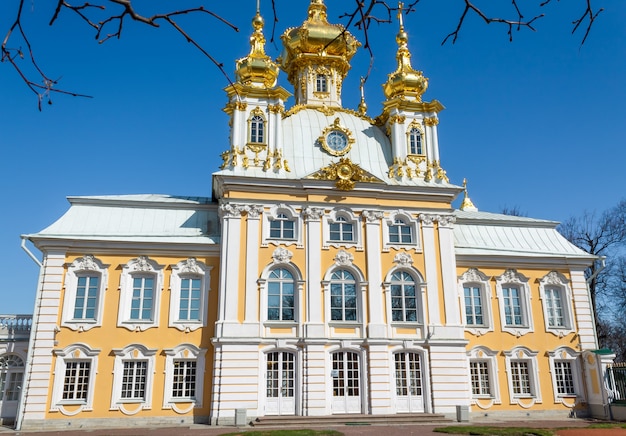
[331,351,361,413]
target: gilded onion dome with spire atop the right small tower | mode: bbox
[383,7,428,102]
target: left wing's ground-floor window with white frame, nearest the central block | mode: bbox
[163,344,206,413]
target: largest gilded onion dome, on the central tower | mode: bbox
[280,0,361,85]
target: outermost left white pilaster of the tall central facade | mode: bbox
[215,203,245,337]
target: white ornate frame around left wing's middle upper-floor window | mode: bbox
[117,256,163,331]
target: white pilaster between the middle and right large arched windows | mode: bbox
[362,210,386,338]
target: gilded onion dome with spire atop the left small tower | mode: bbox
[235,10,279,88]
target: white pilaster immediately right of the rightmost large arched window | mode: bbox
[419,214,441,325]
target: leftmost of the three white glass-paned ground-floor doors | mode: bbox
[265,351,296,415]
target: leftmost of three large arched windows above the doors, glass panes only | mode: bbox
[267,268,296,321]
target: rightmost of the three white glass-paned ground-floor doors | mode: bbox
[394,353,424,413]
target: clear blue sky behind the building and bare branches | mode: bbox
[0,0,626,314]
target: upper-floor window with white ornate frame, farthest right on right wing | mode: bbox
[539,271,574,337]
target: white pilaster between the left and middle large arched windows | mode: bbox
[302,207,325,338]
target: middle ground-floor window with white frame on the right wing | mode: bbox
[504,347,541,405]
